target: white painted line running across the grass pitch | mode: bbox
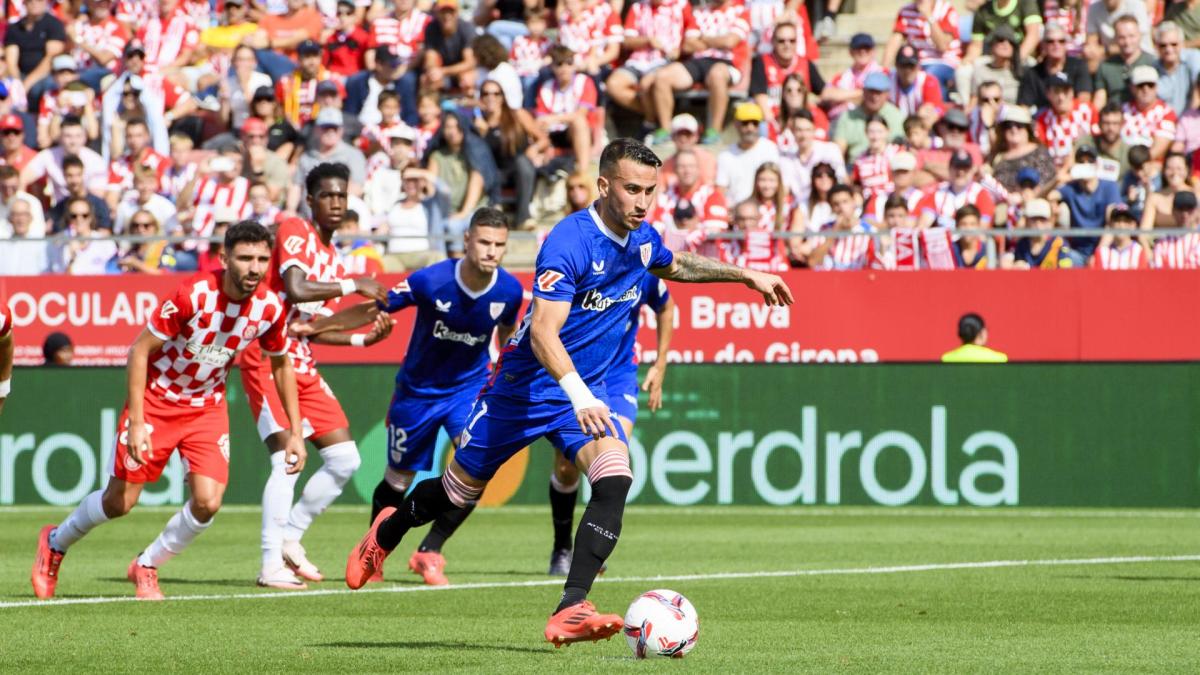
[0,555,1200,609]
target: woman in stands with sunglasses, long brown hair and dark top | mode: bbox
[468,79,547,229]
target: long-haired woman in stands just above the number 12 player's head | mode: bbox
[427,112,499,253]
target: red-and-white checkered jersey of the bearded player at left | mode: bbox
[146,271,289,407]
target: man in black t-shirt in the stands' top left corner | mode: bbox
[4,0,67,103]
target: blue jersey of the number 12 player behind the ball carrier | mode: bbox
[379,259,521,395]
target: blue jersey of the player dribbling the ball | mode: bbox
[491,207,674,401]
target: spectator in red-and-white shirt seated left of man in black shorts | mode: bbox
[606,0,695,133]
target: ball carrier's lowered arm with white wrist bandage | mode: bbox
[529,297,617,438]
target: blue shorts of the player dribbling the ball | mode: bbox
[455,393,629,480]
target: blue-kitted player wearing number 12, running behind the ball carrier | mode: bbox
[294,208,522,586]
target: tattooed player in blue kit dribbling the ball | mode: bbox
[346,138,792,646]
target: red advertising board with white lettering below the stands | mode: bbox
[0,270,1200,365]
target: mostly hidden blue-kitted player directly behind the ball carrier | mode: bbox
[548,275,676,577]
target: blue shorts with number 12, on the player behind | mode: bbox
[388,383,479,471]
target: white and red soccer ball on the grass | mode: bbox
[625,589,700,658]
